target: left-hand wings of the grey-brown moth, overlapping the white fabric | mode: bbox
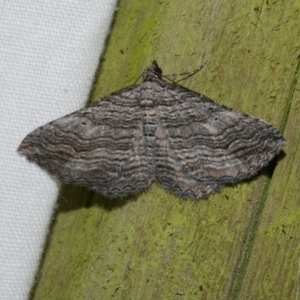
[18,86,153,197]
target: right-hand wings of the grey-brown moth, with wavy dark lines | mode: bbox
[157,81,285,198]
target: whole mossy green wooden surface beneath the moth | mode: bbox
[32,0,300,300]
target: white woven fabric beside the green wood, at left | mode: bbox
[0,0,117,300]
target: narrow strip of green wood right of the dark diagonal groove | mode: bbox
[235,52,300,299]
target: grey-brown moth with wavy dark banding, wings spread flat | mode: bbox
[18,61,285,199]
